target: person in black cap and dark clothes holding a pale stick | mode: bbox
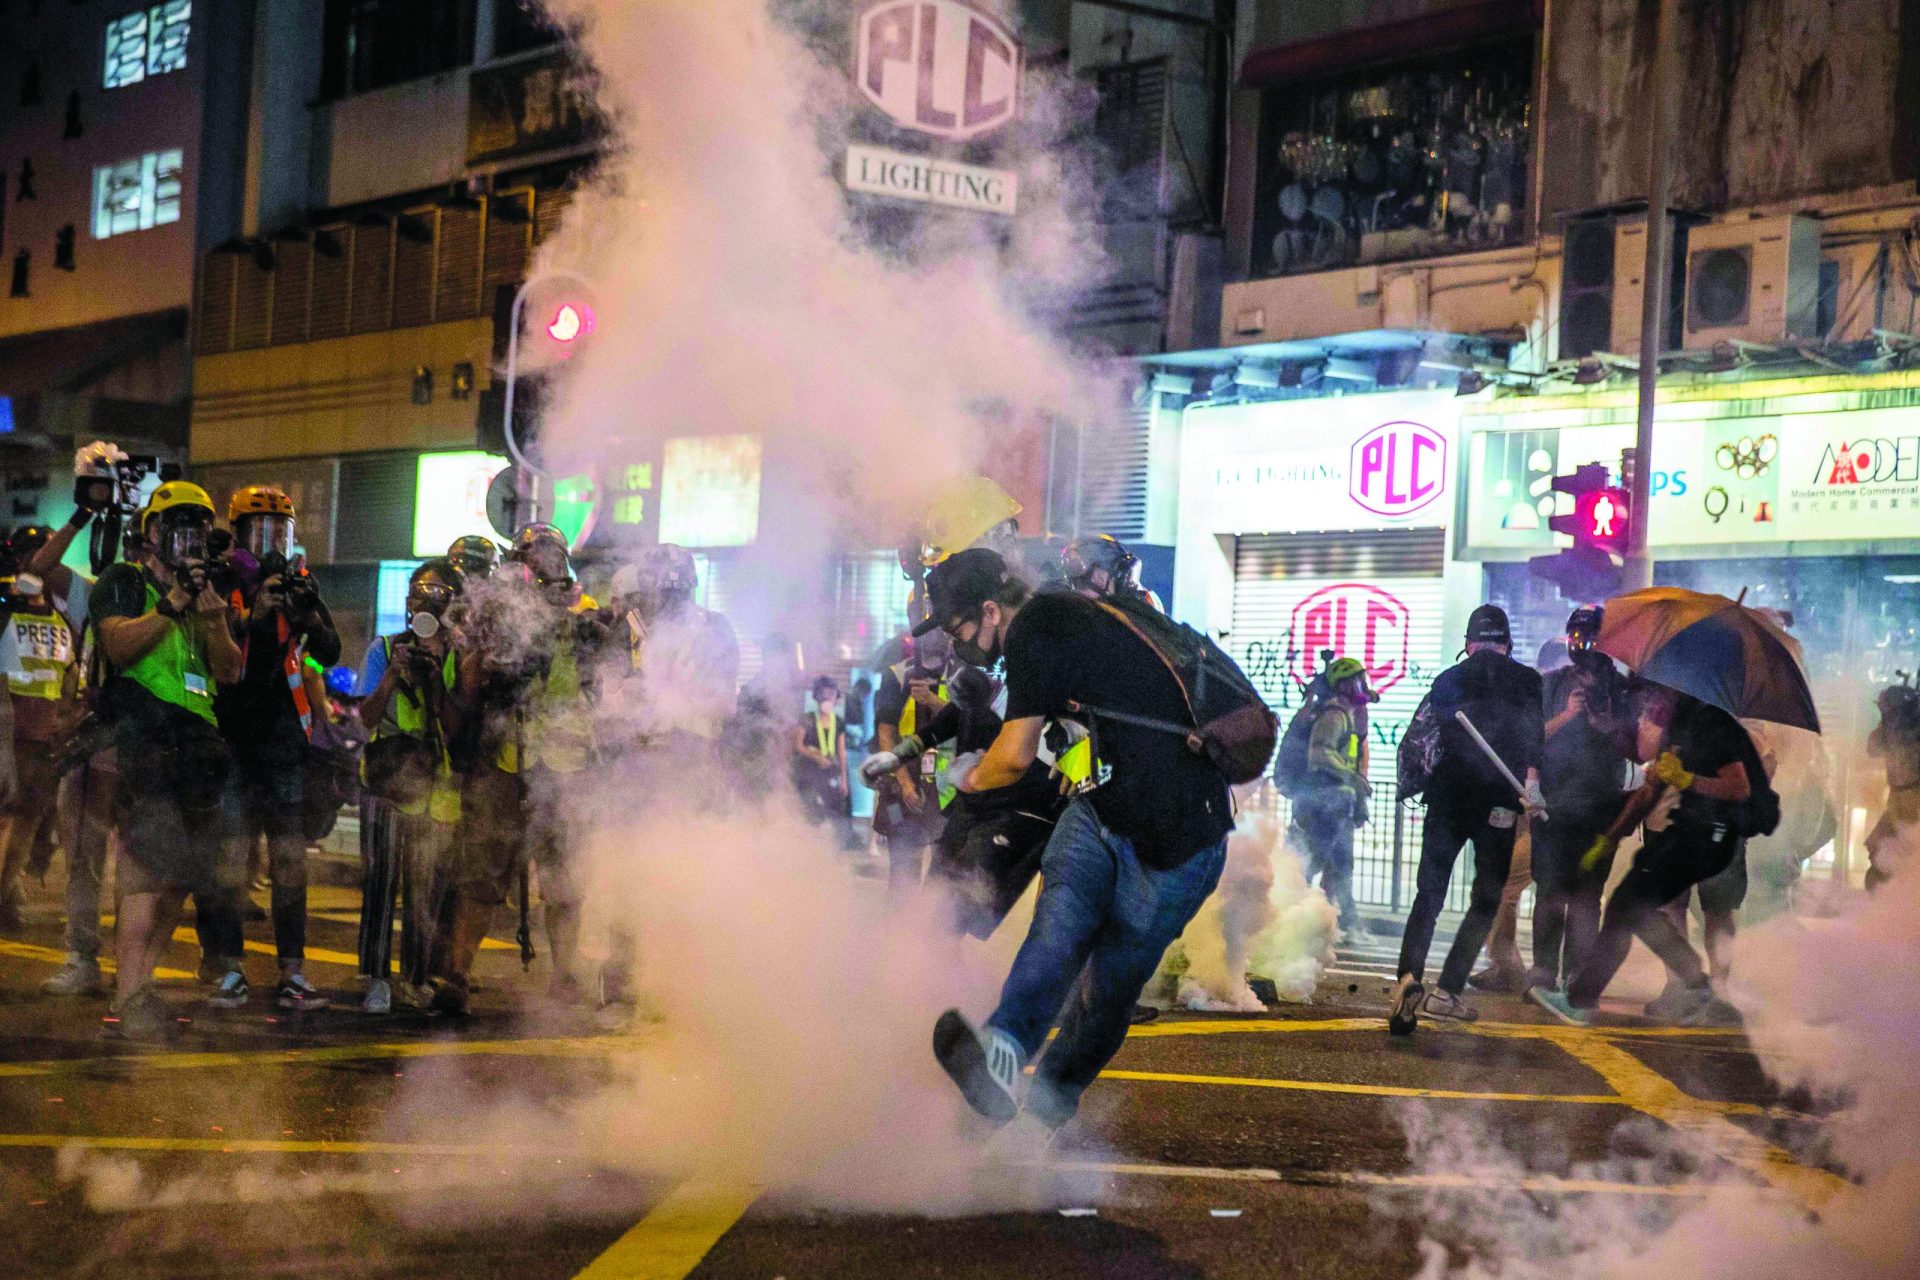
[1386,604,1546,1036]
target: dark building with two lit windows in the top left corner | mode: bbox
[0,0,253,526]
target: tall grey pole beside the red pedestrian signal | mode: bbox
[1622,0,1678,591]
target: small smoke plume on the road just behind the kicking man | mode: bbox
[1179,783,1340,1013]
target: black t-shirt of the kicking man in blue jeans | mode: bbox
[1006,591,1233,869]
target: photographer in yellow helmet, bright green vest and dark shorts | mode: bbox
[92,480,244,1036]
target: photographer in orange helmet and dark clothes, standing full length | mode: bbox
[209,484,340,1009]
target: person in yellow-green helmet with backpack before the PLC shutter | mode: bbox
[1273,658,1380,935]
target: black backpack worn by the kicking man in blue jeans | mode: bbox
[1073,597,1281,785]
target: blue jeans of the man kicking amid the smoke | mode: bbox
[987,798,1227,1126]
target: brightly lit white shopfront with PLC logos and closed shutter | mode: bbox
[1173,391,1480,908]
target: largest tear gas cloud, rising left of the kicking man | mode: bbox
[370,0,1108,1211]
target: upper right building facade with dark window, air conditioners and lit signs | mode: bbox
[1113,0,1920,902]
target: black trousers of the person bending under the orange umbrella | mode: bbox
[1567,821,1740,1009]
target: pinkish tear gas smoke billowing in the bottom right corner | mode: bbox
[1382,859,1920,1280]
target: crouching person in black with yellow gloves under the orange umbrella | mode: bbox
[1528,687,1780,1027]
